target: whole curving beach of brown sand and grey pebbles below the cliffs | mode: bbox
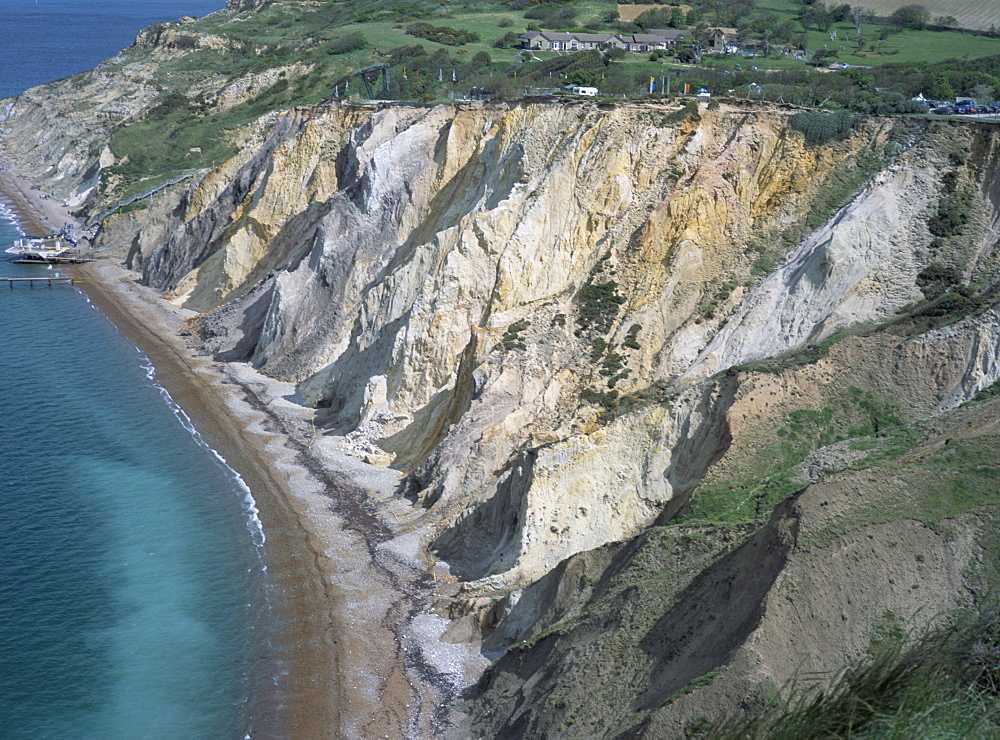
[0,162,486,738]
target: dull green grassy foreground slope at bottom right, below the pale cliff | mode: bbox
[464,368,1000,738]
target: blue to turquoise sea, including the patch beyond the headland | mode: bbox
[0,0,274,740]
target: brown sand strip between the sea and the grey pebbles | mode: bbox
[73,261,342,737]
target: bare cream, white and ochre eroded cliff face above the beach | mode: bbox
[121,103,996,586]
